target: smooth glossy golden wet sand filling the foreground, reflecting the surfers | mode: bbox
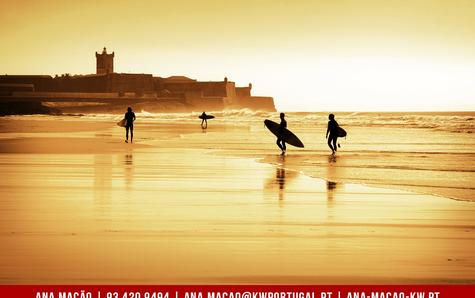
[0,118,475,284]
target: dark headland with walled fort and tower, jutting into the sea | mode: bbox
[0,48,275,115]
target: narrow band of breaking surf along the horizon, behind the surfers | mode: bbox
[6,109,475,133]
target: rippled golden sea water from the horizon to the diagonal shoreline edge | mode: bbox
[4,110,475,201]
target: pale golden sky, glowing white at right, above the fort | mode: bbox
[0,0,475,111]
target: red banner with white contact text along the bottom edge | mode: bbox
[0,285,475,298]
